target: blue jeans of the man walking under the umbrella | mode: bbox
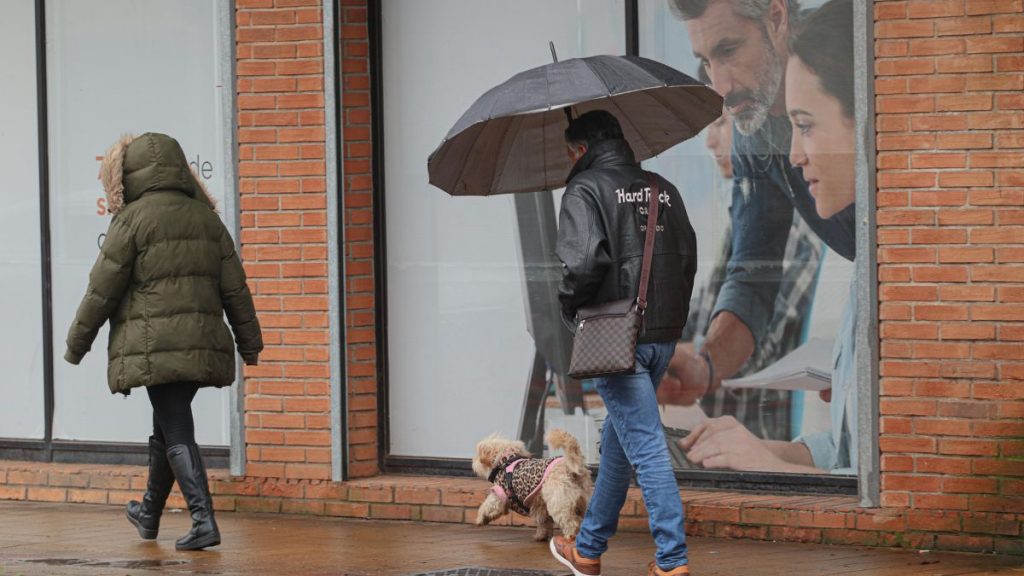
[575,342,688,570]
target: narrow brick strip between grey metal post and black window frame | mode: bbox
[340,0,380,478]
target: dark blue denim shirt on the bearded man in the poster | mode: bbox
[714,116,856,345]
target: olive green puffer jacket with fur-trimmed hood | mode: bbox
[65,133,263,395]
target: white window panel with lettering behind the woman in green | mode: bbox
[46,0,232,446]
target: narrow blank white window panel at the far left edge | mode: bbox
[0,0,44,439]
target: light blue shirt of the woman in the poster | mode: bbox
[794,277,857,475]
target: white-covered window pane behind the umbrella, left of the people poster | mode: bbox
[382,0,626,461]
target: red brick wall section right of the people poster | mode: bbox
[874,0,1024,547]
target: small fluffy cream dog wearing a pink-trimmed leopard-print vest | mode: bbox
[473,429,594,542]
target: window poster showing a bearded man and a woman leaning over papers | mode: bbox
[640,0,857,474]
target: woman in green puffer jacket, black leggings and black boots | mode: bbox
[65,133,263,549]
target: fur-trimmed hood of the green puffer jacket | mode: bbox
[99,132,217,214]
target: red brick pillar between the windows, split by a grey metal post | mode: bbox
[236,0,378,480]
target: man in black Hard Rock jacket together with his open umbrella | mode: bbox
[427,50,723,576]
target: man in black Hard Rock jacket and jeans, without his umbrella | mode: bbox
[550,110,697,576]
